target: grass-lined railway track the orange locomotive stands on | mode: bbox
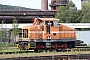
[0,47,90,55]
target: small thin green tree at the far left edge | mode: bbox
[0,20,7,43]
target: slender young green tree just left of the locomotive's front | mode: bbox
[12,19,19,43]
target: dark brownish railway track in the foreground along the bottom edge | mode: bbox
[0,54,90,60]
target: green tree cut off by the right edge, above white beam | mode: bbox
[81,2,90,23]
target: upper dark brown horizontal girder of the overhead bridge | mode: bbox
[0,10,56,16]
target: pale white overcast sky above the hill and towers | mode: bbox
[0,0,81,9]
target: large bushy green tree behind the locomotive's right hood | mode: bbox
[56,1,82,23]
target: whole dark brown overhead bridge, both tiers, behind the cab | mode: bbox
[0,10,57,23]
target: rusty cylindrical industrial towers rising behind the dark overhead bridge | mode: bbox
[41,0,67,10]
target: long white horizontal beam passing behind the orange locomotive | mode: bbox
[0,23,90,28]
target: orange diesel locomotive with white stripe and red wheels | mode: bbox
[18,18,80,51]
